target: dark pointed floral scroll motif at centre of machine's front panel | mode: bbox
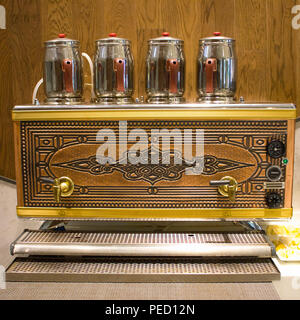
[53,149,253,184]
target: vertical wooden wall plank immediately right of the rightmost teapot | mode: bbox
[234,0,269,101]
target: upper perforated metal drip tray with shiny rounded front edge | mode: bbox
[11,230,274,258]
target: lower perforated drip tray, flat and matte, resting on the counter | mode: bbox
[6,256,280,282]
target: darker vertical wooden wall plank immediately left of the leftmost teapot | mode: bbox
[7,0,43,107]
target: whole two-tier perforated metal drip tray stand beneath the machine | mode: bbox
[6,221,280,282]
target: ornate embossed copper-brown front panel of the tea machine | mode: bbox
[19,120,288,209]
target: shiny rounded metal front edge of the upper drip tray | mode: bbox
[13,243,272,258]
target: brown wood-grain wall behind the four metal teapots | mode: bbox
[0,0,300,178]
